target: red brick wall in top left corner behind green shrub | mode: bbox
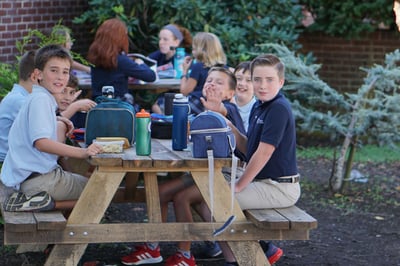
[0,0,92,63]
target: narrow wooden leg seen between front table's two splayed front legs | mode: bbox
[144,172,162,223]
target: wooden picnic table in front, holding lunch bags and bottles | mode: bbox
[3,139,317,266]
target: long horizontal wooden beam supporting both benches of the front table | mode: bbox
[4,222,308,245]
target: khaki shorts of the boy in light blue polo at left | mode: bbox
[21,166,88,201]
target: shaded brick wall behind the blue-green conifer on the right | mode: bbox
[299,30,400,92]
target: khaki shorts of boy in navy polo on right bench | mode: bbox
[235,179,301,210]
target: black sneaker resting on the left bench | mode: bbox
[4,191,55,212]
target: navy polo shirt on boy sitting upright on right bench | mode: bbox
[246,92,297,179]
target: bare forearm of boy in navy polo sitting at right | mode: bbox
[235,142,275,192]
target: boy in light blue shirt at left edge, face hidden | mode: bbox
[0,51,36,162]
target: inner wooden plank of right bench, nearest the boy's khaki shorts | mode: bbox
[244,209,290,229]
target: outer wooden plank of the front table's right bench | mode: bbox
[276,206,318,230]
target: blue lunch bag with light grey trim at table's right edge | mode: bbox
[190,111,236,158]
